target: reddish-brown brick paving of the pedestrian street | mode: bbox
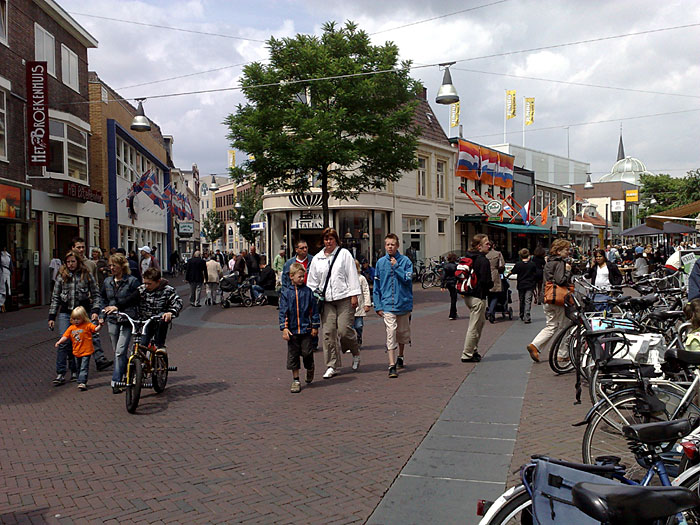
[0,288,516,523]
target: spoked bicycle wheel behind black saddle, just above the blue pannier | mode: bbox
[581,387,700,479]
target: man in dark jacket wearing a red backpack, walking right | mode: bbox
[455,233,493,363]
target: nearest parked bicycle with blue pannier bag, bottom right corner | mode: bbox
[477,419,700,525]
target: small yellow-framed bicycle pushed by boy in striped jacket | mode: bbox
[115,312,177,414]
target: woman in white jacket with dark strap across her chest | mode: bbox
[306,228,361,379]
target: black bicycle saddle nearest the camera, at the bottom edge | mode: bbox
[571,482,700,525]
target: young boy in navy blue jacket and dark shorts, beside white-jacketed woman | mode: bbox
[279,262,321,394]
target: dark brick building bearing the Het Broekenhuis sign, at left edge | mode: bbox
[0,0,105,309]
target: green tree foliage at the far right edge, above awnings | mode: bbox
[639,170,700,218]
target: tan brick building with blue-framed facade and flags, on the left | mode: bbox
[88,71,173,269]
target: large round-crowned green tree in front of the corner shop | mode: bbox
[225,22,420,226]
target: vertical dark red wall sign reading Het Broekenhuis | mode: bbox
[26,62,49,166]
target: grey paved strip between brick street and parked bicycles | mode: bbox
[368,307,549,524]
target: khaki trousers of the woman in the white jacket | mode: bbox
[321,297,360,370]
